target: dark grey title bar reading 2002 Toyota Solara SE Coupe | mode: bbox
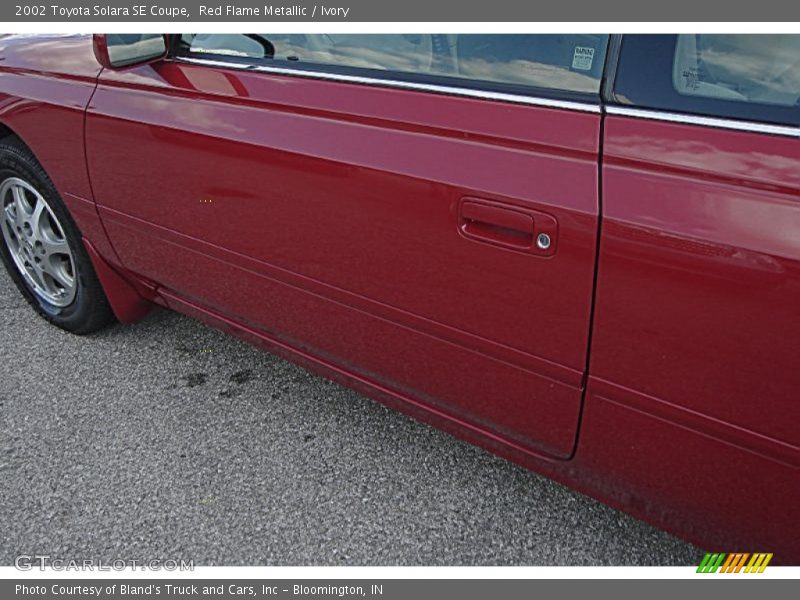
[0,0,800,25]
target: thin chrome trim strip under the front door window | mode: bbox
[175,56,602,114]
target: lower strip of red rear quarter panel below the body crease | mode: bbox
[572,379,800,565]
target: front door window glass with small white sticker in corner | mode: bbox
[180,33,609,95]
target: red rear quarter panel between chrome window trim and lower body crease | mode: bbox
[591,117,800,454]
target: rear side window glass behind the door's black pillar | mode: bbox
[613,34,800,125]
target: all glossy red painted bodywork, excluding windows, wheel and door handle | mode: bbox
[0,37,800,564]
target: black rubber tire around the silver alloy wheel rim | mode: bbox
[0,136,115,335]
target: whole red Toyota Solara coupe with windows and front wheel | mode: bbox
[0,34,800,564]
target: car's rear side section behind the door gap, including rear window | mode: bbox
[578,35,800,562]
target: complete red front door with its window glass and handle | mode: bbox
[86,35,607,458]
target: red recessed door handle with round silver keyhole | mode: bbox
[458,198,558,256]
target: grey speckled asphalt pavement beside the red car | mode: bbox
[0,268,702,565]
